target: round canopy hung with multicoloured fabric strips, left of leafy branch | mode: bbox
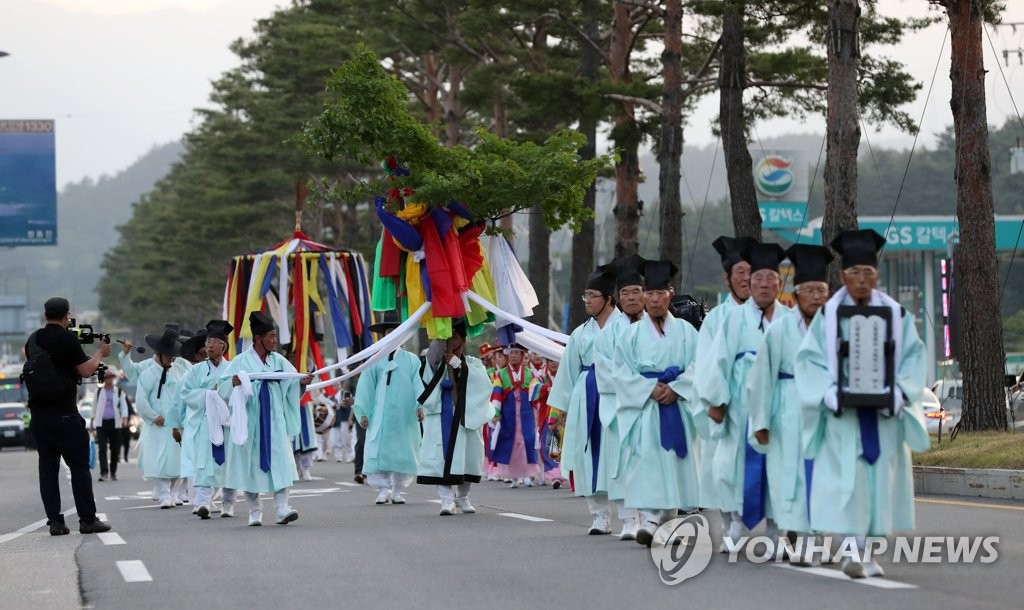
[223,230,373,378]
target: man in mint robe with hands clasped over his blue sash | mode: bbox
[611,261,699,547]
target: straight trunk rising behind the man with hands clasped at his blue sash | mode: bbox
[657,0,684,290]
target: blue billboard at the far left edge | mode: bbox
[0,120,57,246]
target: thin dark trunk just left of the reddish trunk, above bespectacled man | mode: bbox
[558,0,601,331]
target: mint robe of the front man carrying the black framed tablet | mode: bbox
[796,289,931,536]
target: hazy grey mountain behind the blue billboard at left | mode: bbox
[0,142,183,314]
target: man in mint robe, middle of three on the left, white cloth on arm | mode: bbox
[178,320,234,519]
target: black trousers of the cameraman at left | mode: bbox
[32,408,96,525]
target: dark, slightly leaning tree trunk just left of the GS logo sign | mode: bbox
[719,0,761,241]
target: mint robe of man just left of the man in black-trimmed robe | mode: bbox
[353,349,423,475]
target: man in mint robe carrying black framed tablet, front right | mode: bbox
[796,229,931,578]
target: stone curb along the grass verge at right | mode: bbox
[913,466,1024,499]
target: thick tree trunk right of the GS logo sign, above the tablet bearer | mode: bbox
[821,0,860,290]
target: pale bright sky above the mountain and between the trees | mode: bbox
[0,0,1024,187]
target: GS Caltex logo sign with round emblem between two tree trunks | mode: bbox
[751,148,810,228]
